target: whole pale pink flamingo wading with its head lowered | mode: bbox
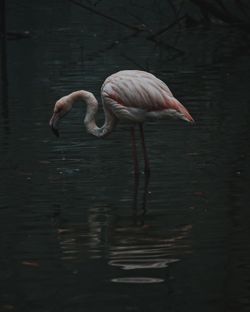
[49,70,194,175]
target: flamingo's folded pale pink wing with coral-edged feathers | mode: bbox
[102,70,193,122]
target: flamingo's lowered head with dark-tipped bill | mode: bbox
[49,96,72,137]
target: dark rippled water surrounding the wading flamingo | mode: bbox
[0,1,250,312]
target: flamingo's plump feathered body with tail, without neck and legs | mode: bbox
[101,70,193,123]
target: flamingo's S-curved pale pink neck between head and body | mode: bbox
[68,90,116,138]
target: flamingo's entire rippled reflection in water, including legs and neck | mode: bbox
[54,172,192,283]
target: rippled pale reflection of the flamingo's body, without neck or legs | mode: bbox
[109,226,192,270]
